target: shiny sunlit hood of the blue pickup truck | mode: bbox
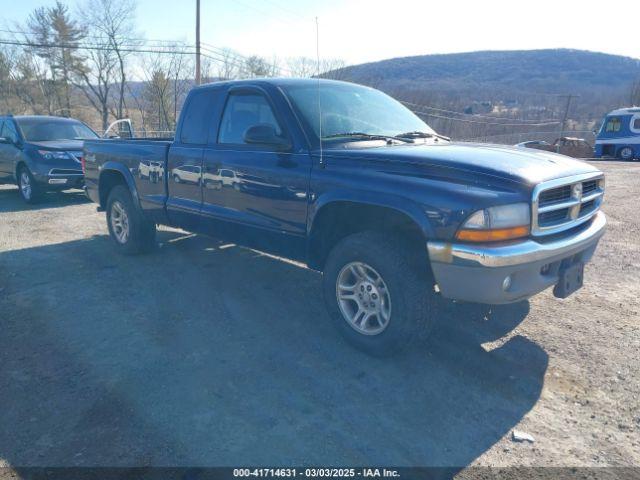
[327,143,599,185]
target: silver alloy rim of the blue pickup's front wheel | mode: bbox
[336,262,391,335]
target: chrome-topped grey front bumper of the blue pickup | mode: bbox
[427,212,607,304]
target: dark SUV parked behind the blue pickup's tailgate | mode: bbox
[0,115,98,203]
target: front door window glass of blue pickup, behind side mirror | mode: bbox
[218,93,282,145]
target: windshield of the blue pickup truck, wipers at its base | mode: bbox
[284,82,435,141]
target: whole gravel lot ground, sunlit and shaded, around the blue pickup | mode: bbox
[0,162,640,472]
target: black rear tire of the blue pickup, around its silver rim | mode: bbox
[107,185,156,255]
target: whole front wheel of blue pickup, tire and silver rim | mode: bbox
[323,232,435,356]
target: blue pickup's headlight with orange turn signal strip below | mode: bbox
[456,203,531,242]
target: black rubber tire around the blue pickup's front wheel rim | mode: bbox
[323,232,435,357]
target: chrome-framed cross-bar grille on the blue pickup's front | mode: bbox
[531,173,604,235]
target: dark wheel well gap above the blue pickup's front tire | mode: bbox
[307,202,429,270]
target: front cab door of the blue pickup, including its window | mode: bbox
[202,87,311,256]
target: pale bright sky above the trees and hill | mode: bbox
[0,0,640,64]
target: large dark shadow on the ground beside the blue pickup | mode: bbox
[0,232,548,473]
